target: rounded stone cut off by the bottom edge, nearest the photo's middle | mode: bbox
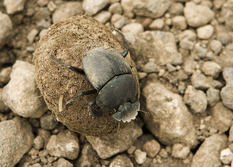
[109,154,134,167]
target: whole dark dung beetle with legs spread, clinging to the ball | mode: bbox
[50,30,140,122]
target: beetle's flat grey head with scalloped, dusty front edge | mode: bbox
[113,101,140,122]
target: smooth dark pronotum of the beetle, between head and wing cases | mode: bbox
[96,74,138,109]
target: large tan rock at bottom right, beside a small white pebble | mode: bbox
[191,134,227,167]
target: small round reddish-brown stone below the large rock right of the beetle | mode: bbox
[143,139,160,158]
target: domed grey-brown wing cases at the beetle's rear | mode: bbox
[82,47,132,90]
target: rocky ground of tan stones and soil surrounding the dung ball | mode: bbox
[0,0,233,167]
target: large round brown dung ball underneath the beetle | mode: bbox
[34,16,139,136]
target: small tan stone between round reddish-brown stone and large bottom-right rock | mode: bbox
[172,143,190,159]
